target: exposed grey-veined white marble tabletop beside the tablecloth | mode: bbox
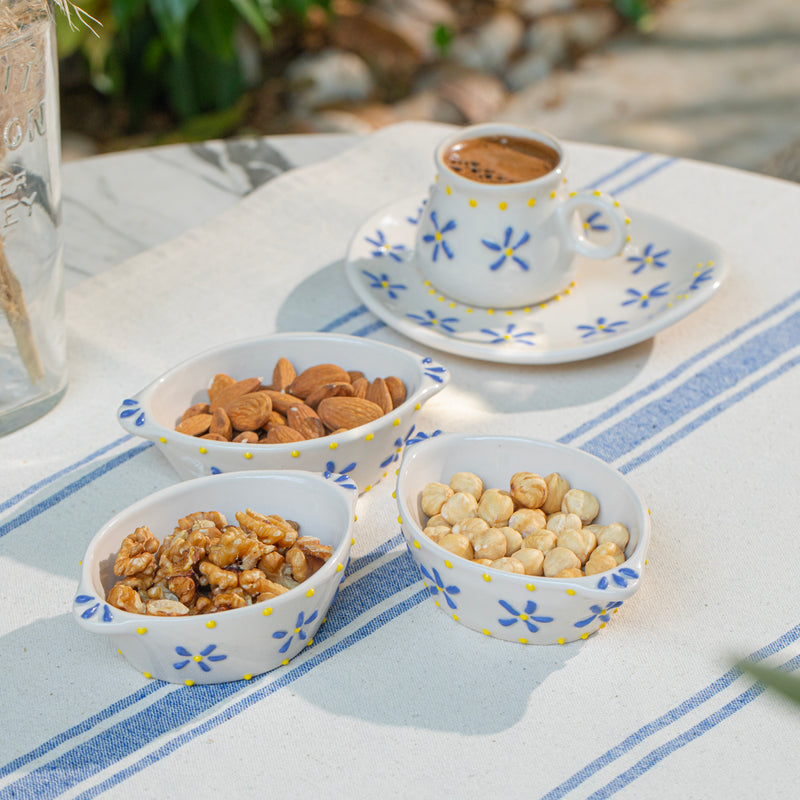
[62,134,358,289]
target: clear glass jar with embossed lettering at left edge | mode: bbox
[0,0,67,434]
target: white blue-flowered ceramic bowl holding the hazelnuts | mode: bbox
[397,434,650,644]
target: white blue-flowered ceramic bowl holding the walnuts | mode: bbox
[73,470,358,685]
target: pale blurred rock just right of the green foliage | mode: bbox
[286,48,375,109]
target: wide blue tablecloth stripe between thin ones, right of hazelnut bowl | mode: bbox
[581,312,800,463]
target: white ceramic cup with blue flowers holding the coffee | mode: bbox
[414,123,629,308]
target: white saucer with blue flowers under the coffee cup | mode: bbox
[346,195,728,364]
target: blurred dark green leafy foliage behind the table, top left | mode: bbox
[58,0,330,130]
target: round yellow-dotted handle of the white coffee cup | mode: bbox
[558,190,630,258]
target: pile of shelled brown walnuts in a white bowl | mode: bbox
[107,508,333,617]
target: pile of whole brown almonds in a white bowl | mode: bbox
[175,358,406,444]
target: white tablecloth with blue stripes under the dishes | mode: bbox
[0,123,800,799]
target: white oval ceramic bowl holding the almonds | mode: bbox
[117,333,449,493]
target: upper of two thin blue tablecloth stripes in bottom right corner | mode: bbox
[541,625,800,800]
